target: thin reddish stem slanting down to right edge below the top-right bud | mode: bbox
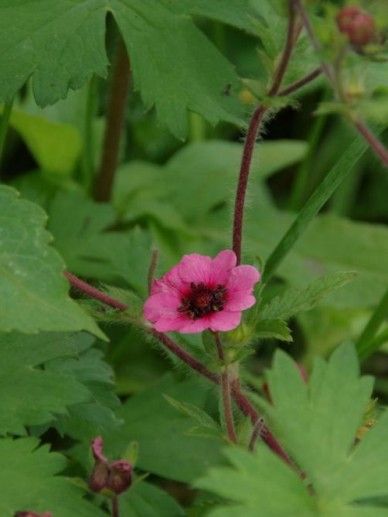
[292,0,388,167]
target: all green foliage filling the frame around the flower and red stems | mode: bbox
[0,0,388,517]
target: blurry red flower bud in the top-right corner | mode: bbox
[337,5,376,47]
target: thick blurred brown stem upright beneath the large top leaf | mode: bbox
[94,38,130,201]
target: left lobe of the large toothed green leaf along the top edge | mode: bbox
[0,0,108,106]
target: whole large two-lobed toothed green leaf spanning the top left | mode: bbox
[0,0,243,138]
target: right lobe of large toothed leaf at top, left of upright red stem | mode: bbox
[111,0,242,138]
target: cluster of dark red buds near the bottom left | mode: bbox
[89,436,132,495]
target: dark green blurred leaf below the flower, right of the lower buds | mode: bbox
[105,375,223,482]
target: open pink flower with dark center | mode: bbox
[144,250,260,333]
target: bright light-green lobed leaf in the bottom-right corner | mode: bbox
[196,345,388,517]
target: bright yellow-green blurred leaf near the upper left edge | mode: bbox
[10,109,82,176]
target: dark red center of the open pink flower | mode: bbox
[178,282,226,320]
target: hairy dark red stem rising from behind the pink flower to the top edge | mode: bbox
[232,2,295,264]
